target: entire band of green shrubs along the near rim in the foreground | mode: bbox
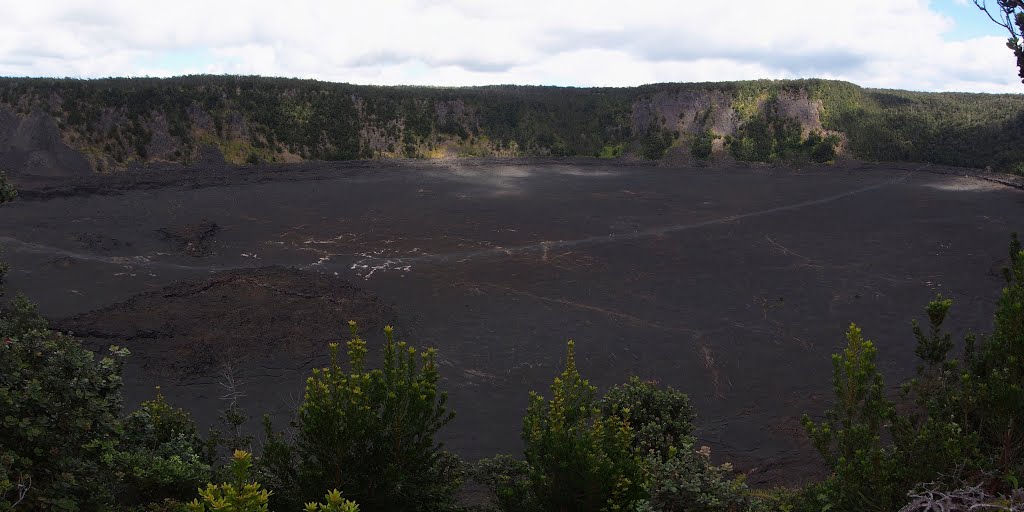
[0,175,1024,512]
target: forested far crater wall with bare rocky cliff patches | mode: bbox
[0,76,1024,171]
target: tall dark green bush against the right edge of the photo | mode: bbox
[892,236,1024,492]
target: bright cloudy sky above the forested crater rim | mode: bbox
[0,0,1024,93]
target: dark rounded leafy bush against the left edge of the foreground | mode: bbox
[0,301,128,510]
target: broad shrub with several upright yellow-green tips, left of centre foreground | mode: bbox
[295,323,461,510]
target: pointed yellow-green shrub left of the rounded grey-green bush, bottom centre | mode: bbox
[522,341,645,511]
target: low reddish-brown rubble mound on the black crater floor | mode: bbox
[57,266,394,376]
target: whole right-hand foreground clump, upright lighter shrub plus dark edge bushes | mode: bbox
[804,236,1024,511]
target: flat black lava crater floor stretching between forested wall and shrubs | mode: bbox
[0,160,1024,484]
